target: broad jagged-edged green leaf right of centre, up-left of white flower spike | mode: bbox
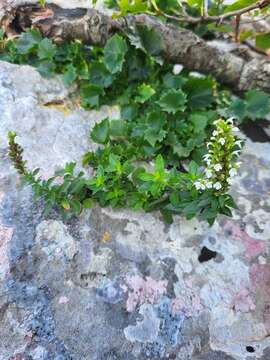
[158,89,186,114]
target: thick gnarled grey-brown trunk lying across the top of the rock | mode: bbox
[1,5,270,93]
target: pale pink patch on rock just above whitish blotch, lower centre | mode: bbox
[126,275,168,312]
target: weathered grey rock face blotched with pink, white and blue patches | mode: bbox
[0,59,270,360]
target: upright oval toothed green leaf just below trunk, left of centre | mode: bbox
[104,35,128,74]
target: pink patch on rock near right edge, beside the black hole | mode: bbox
[225,221,266,259]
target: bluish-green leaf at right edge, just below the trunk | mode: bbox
[245,90,270,120]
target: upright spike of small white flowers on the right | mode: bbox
[194,118,243,193]
